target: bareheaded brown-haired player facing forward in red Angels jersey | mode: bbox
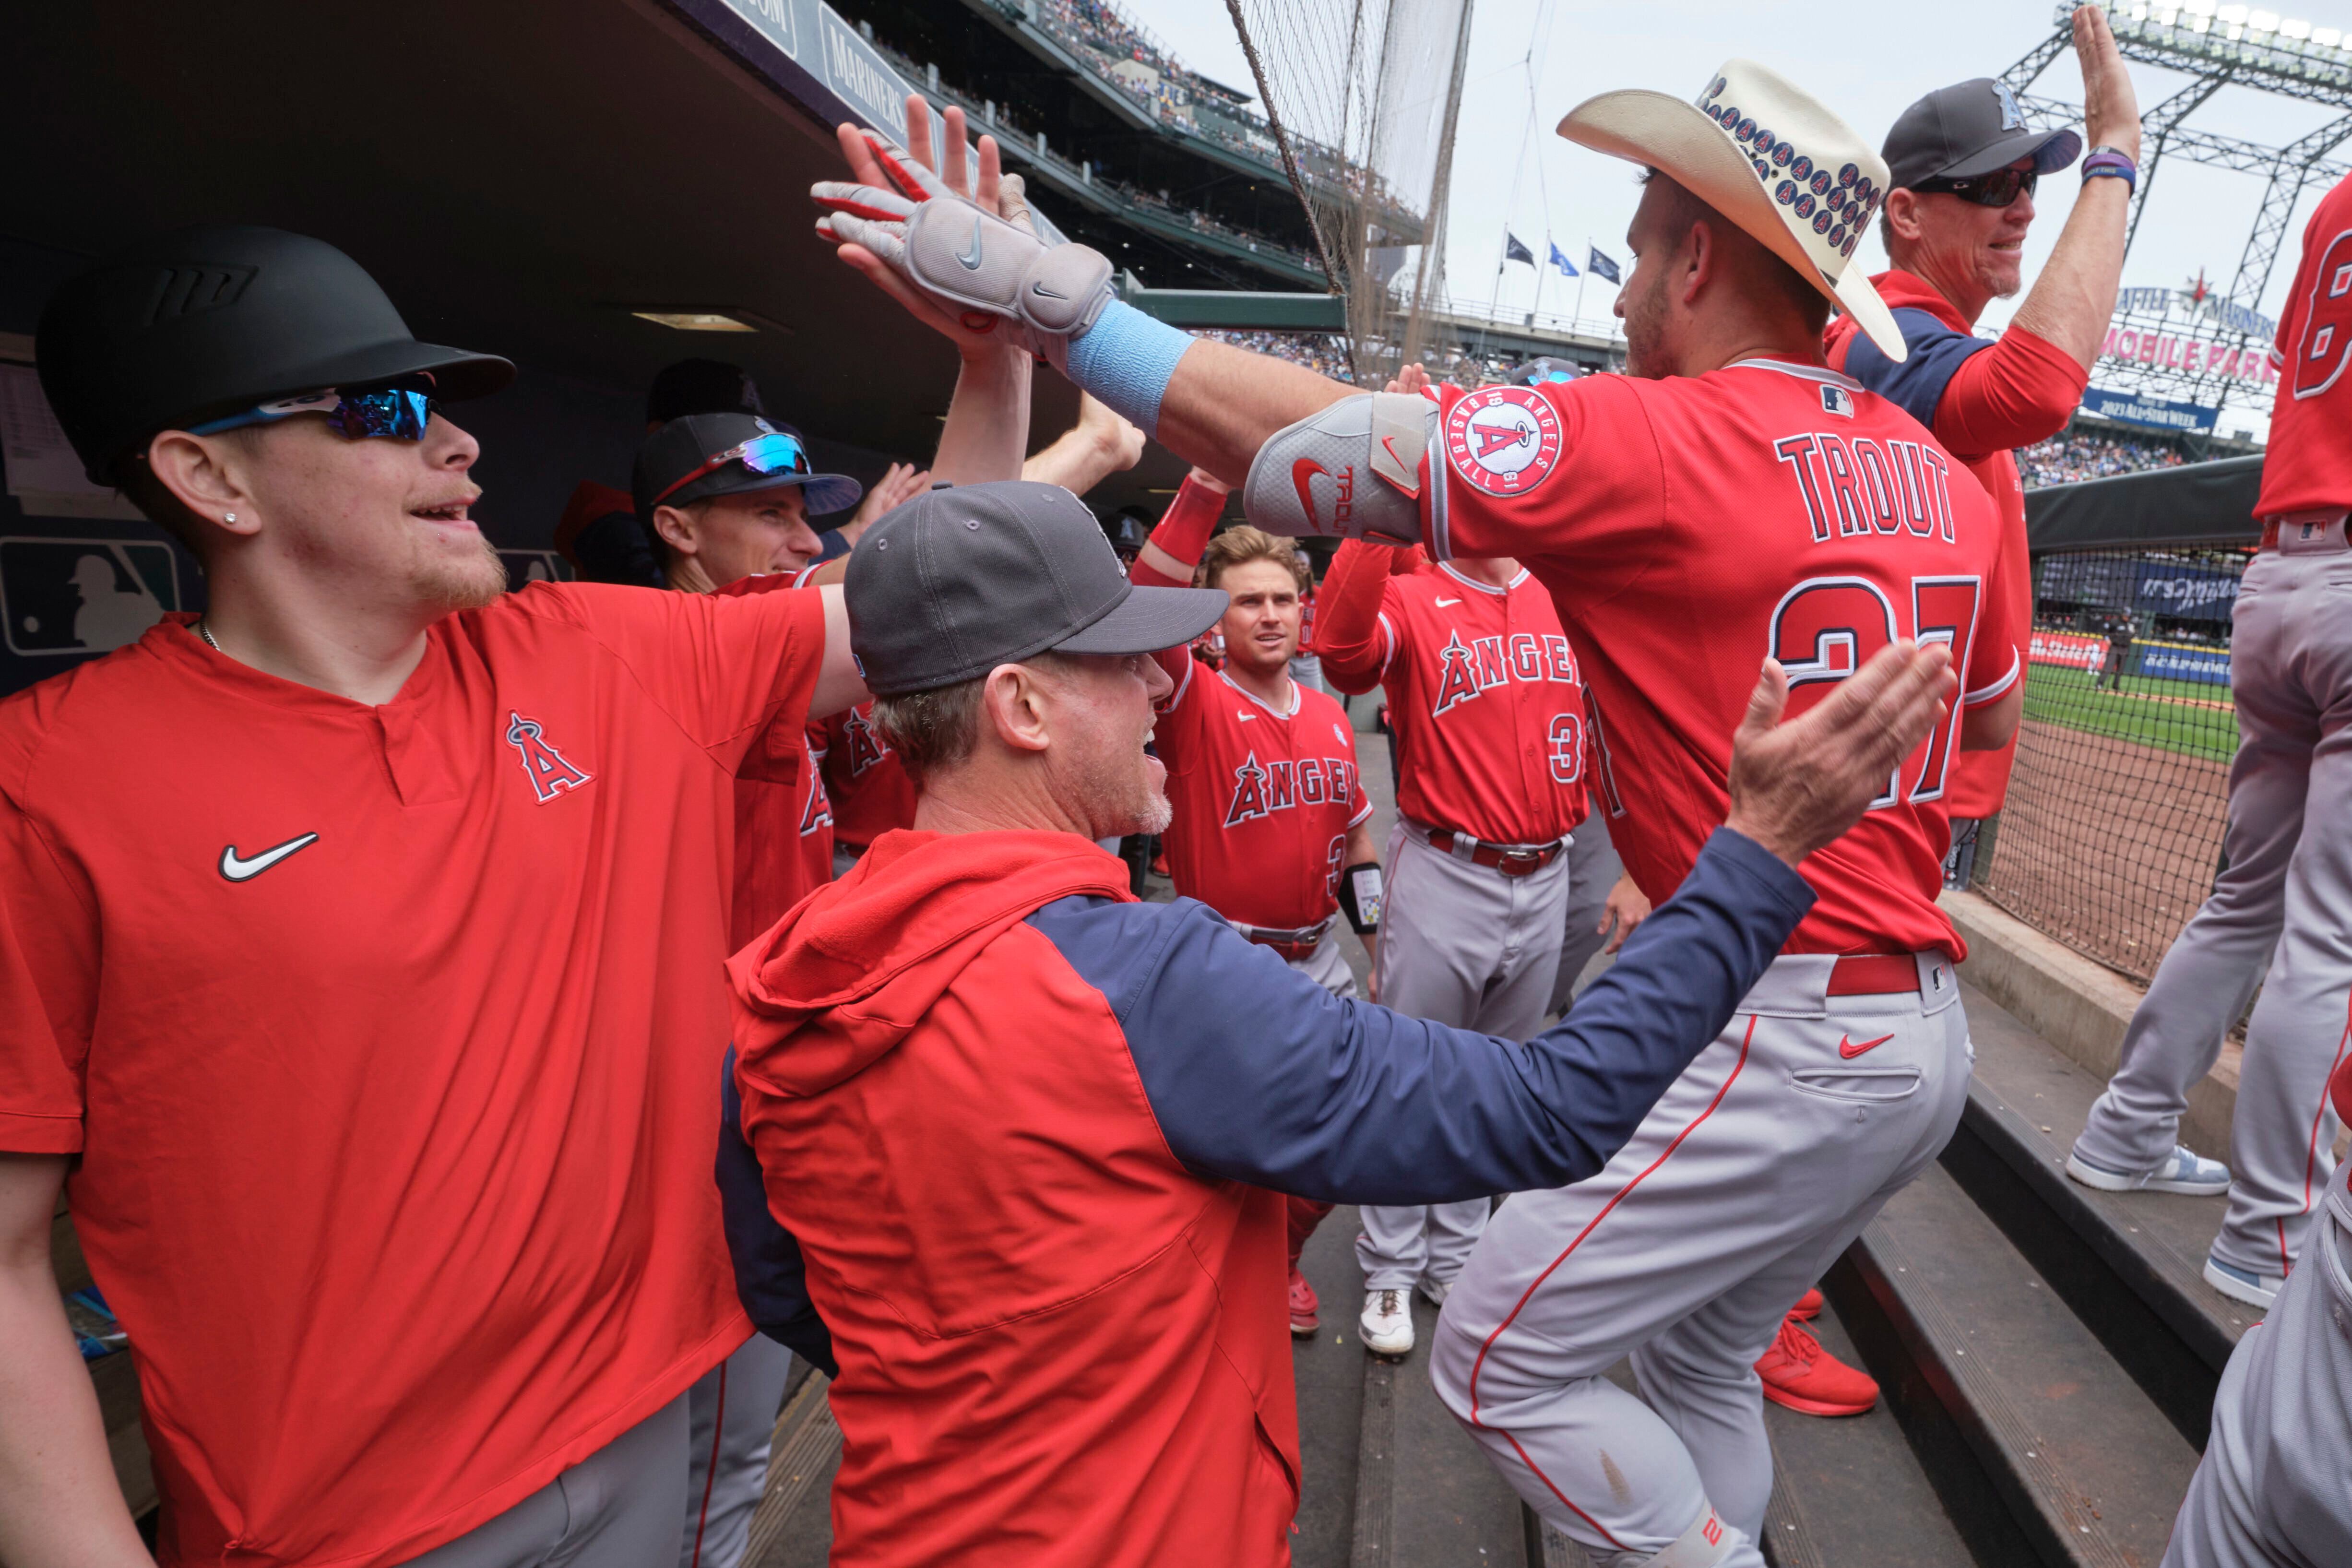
[1131,473,1380,1335]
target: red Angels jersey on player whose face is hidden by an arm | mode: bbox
[1380,564,1585,844]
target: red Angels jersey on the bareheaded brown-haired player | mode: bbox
[1152,658,1371,931]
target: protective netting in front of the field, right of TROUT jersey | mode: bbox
[1973,550,2248,980]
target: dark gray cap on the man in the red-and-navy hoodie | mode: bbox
[844,480,1228,696]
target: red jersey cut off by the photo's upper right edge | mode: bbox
[2253,176,2352,517]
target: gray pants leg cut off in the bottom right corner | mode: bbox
[2164,1168,2352,1568]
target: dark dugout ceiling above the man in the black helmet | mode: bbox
[0,0,1183,522]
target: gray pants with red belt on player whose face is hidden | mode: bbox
[1355,818,1569,1291]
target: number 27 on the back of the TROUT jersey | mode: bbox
[1771,576,1985,811]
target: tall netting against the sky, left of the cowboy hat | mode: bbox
[1225,0,1470,386]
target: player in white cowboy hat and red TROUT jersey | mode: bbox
[816,61,2025,1568]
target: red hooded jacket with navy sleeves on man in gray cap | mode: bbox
[720,830,1813,1568]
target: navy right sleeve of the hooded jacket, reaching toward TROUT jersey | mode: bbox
[1068,830,1813,1204]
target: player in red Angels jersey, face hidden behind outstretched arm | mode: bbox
[1317,522,1585,1356]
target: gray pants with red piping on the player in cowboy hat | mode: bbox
[1430,954,1971,1568]
